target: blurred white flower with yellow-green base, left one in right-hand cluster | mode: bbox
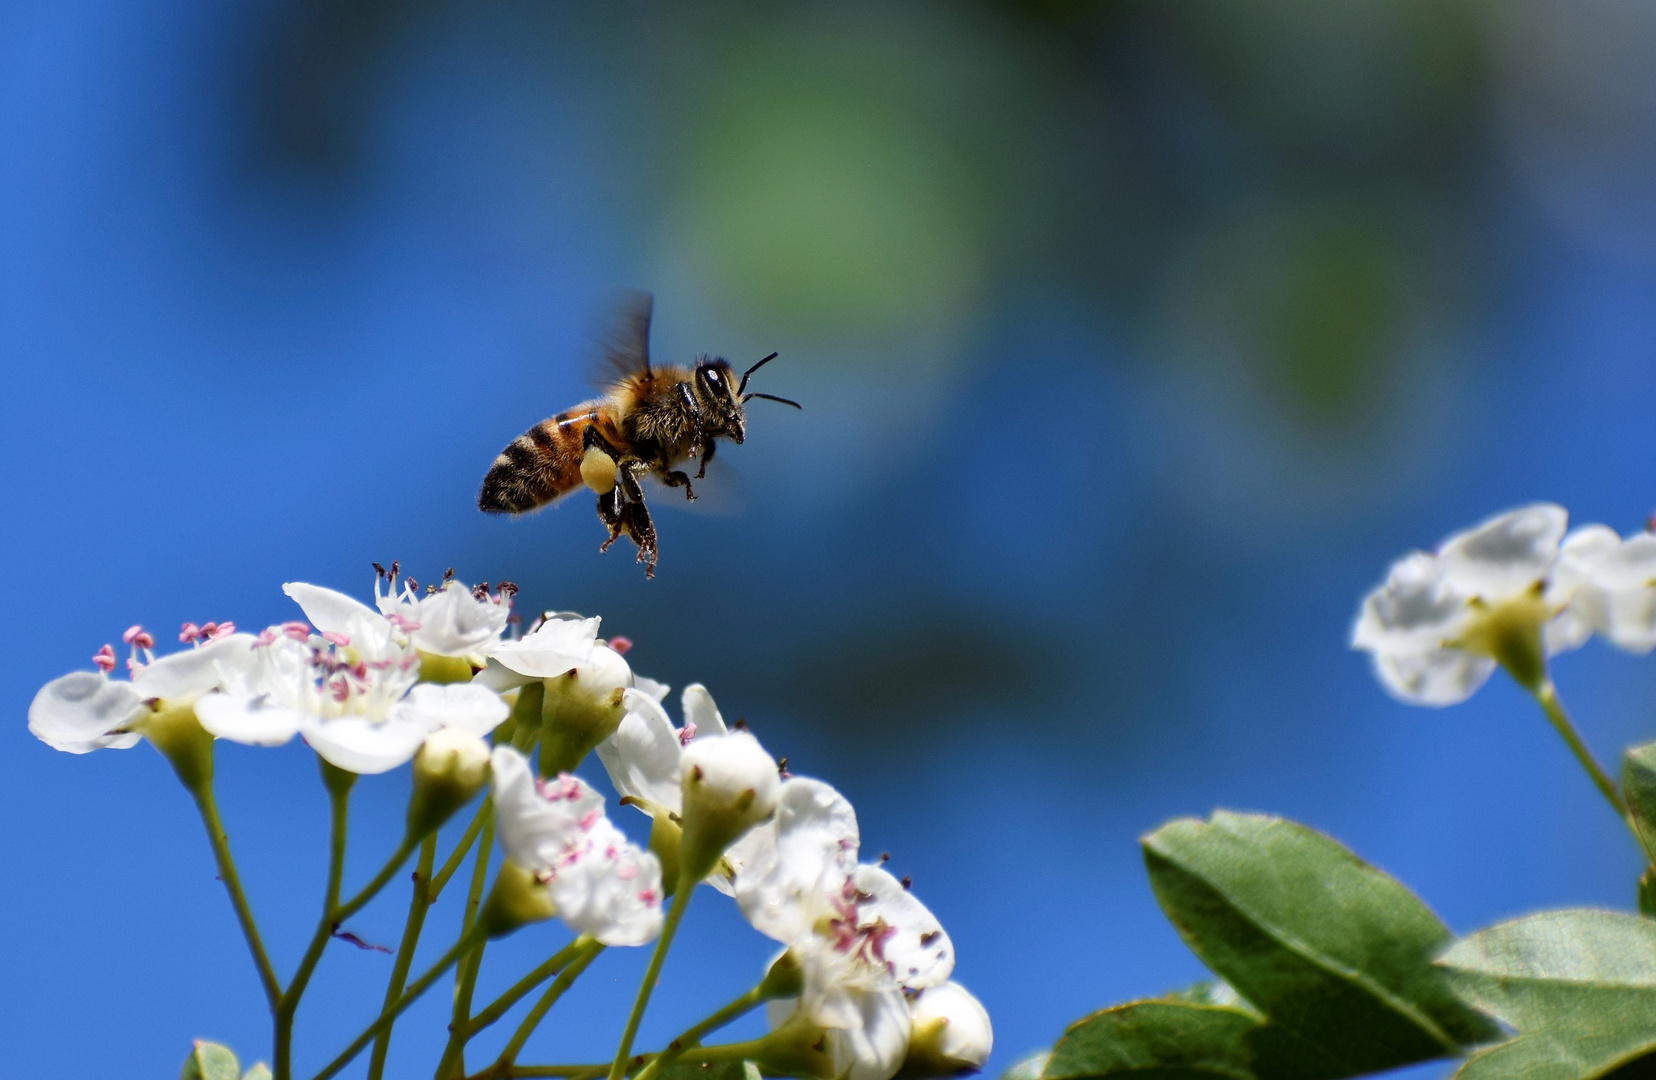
[1351,504,1586,706]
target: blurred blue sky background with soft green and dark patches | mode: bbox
[0,0,1656,1077]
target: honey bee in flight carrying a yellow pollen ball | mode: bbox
[477,286,800,578]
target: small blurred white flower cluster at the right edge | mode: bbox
[1351,504,1656,706]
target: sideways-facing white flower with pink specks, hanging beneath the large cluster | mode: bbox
[493,747,662,946]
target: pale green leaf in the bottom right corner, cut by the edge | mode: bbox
[1439,909,1656,1080]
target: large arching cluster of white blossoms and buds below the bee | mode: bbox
[28,567,992,1080]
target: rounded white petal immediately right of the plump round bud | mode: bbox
[734,777,858,944]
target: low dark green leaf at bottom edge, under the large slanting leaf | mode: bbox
[1042,997,1348,1080]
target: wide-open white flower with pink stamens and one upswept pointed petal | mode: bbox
[195,583,508,774]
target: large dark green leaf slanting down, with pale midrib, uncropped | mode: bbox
[1143,810,1497,1077]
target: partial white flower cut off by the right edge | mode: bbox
[1553,525,1656,654]
